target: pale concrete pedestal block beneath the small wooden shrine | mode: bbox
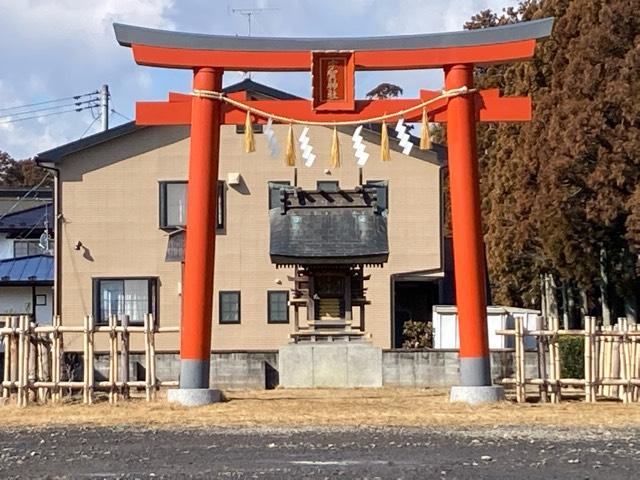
[278,342,382,388]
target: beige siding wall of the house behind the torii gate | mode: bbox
[59,125,441,351]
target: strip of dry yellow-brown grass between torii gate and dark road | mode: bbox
[0,388,640,428]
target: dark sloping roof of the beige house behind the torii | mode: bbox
[35,79,446,165]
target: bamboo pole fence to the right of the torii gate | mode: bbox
[496,316,640,403]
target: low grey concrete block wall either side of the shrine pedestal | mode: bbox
[76,350,538,389]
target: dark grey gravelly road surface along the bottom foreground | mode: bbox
[0,427,640,480]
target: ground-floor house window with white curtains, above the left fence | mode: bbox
[93,278,157,325]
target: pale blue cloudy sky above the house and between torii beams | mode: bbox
[0,0,516,159]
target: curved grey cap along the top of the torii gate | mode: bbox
[113,18,553,52]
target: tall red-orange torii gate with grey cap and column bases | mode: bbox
[114,18,553,404]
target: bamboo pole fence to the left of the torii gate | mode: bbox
[0,315,179,406]
